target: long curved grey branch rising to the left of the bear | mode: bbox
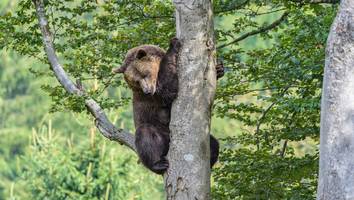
[33,0,135,151]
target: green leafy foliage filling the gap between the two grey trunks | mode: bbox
[210,1,336,199]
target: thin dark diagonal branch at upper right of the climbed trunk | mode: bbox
[217,12,289,49]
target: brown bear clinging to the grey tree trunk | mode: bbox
[113,38,224,174]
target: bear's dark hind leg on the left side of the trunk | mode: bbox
[135,124,170,174]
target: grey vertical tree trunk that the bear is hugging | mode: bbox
[165,0,216,200]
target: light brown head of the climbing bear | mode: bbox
[113,45,165,95]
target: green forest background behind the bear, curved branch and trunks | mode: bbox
[0,0,336,200]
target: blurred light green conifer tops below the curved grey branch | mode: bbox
[23,124,163,200]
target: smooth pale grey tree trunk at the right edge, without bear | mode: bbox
[317,0,354,200]
